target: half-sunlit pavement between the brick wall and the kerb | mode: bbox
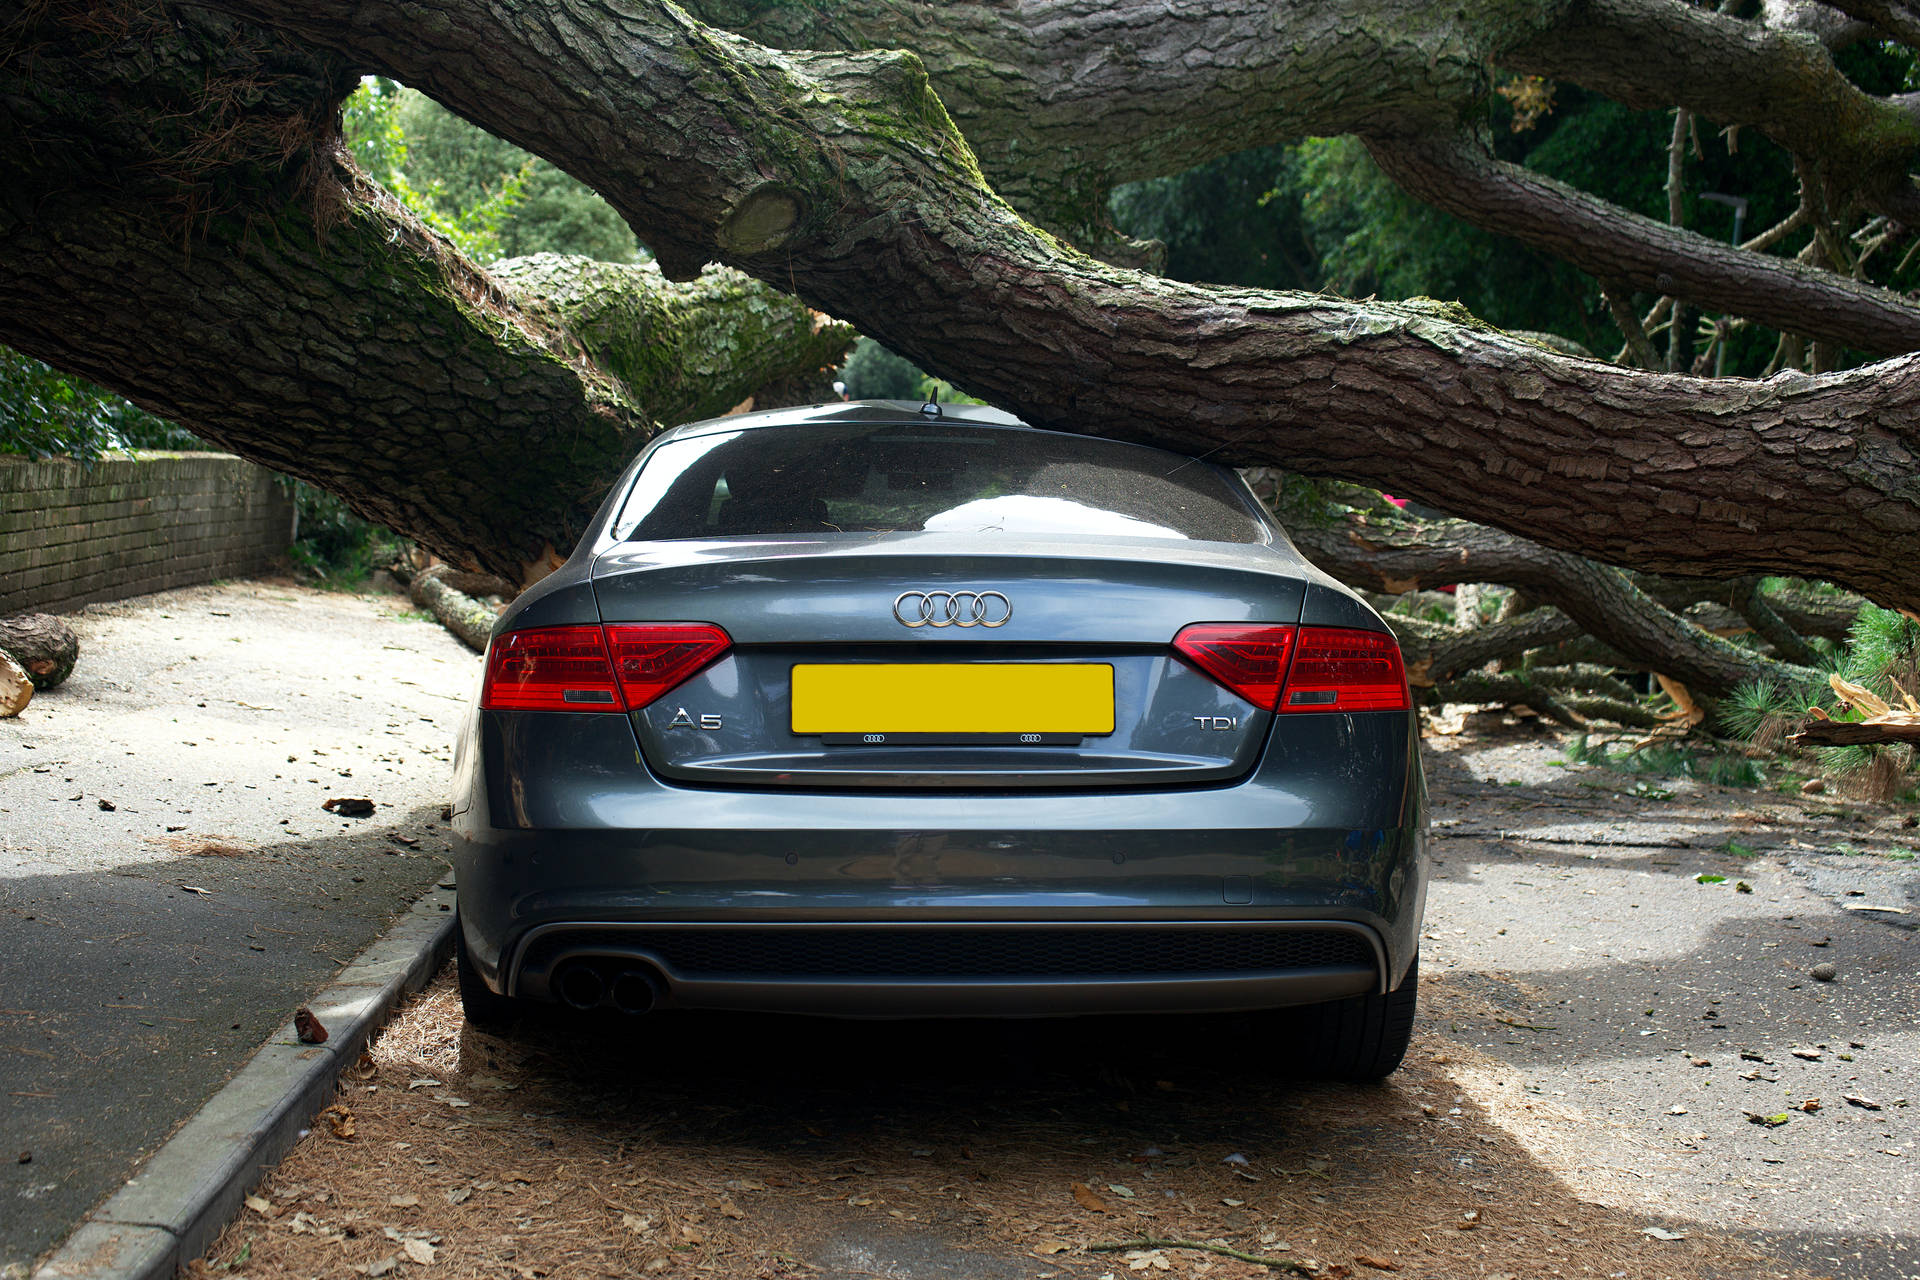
[0,581,478,1274]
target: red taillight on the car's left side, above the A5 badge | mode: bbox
[480,622,732,712]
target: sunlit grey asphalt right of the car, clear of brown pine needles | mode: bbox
[1425,735,1920,1280]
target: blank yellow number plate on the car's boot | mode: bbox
[793,662,1114,735]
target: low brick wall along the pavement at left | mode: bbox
[0,453,294,614]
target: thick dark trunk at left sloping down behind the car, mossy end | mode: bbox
[0,4,851,581]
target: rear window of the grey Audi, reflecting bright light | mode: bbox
[612,424,1265,543]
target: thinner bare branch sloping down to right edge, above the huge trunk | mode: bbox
[1365,134,1920,353]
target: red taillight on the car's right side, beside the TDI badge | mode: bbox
[1173,622,1411,712]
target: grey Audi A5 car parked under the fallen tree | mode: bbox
[453,401,1427,1079]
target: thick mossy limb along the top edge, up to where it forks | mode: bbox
[685,0,1559,265]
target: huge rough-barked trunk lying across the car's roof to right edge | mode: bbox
[135,0,1920,603]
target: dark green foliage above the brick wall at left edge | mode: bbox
[0,339,205,462]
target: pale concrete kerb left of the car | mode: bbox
[33,887,453,1280]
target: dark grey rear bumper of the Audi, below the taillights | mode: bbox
[441,712,1427,1015]
